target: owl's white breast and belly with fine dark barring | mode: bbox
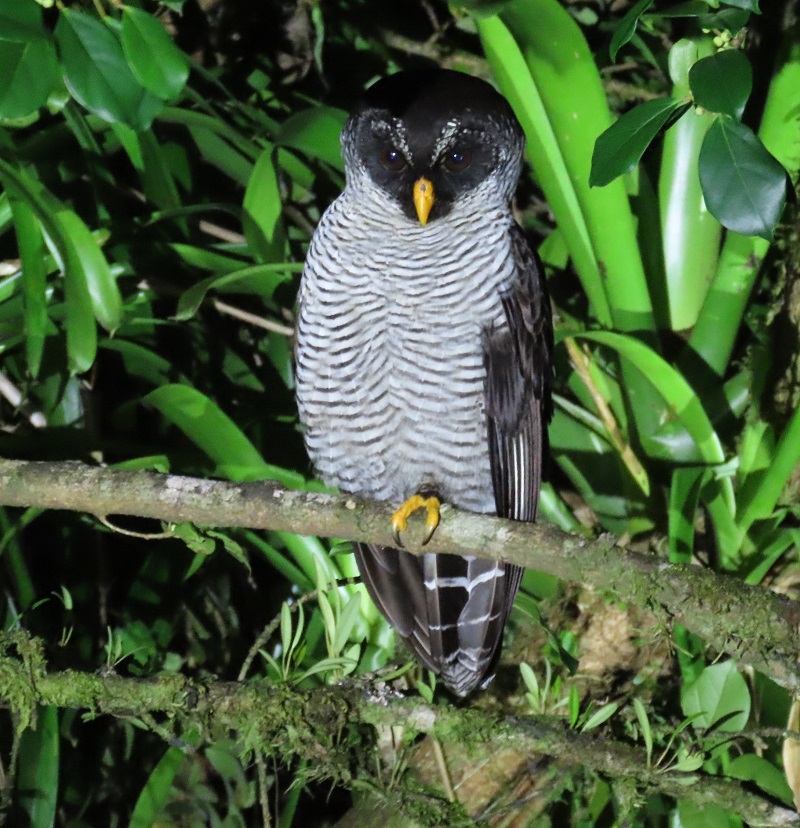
[296,187,514,512]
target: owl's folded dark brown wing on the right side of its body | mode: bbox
[484,226,553,608]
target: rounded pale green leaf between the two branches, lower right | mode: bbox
[681,659,750,732]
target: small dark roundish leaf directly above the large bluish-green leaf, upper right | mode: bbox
[689,49,753,119]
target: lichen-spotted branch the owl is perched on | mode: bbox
[0,460,800,693]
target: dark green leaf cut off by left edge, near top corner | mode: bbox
[0,37,58,118]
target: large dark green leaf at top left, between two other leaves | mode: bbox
[55,9,163,130]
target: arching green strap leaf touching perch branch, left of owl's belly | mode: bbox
[142,385,304,487]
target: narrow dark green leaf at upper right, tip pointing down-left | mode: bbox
[589,98,689,187]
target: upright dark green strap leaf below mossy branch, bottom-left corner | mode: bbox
[15,706,60,828]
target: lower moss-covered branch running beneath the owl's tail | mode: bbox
[0,633,800,826]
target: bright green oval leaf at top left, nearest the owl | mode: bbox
[121,6,189,101]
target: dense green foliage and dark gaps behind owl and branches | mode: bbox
[0,0,800,828]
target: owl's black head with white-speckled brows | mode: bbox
[342,70,523,224]
